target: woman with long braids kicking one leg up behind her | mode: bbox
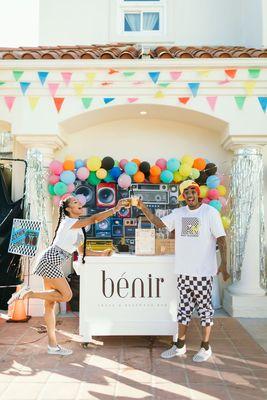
[8,196,130,356]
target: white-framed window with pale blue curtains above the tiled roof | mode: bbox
[120,0,163,35]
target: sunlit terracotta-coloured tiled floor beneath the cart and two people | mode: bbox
[0,317,267,400]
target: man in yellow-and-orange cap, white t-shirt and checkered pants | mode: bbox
[138,180,229,362]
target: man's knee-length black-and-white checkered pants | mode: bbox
[177,275,214,326]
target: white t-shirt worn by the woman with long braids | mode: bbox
[53,216,83,253]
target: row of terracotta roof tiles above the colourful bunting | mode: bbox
[0,43,267,60]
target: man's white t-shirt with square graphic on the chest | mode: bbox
[161,204,225,277]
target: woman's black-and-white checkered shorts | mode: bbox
[33,246,71,278]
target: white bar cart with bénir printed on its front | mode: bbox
[74,254,177,345]
